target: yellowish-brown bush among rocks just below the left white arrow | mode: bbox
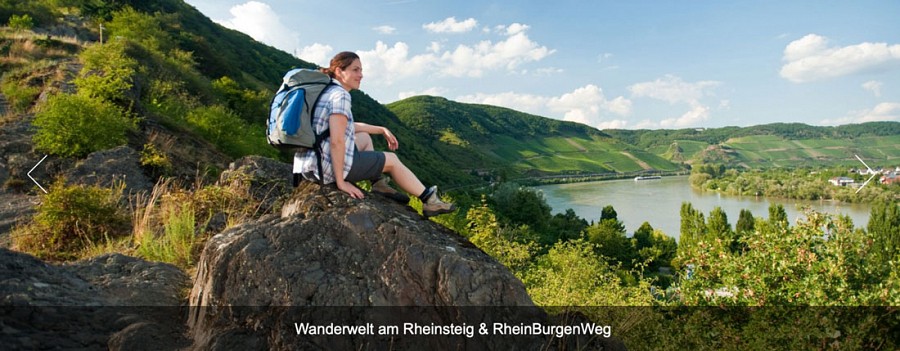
[12,180,129,260]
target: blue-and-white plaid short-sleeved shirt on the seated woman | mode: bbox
[294,79,356,184]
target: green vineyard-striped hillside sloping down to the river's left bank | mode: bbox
[387,96,680,184]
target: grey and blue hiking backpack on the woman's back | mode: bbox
[266,68,334,152]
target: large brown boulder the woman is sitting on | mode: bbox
[189,183,546,350]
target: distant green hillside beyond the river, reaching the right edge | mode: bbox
[605,122,900,168]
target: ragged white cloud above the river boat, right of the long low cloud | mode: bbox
[628,75,729,128]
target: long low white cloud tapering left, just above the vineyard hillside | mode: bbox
[456,84,631,128]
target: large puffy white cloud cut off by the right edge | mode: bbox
[781,34,900,83]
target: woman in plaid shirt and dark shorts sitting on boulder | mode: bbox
[294,51,456,217]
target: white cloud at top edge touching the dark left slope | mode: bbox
[216,1,300,52]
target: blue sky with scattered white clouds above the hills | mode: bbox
[187,0,900,129]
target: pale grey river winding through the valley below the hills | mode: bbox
[535,176,872,239]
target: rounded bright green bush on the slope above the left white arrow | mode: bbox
[34,94,137,157]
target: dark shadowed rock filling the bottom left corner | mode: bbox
[0,248,191,350]
